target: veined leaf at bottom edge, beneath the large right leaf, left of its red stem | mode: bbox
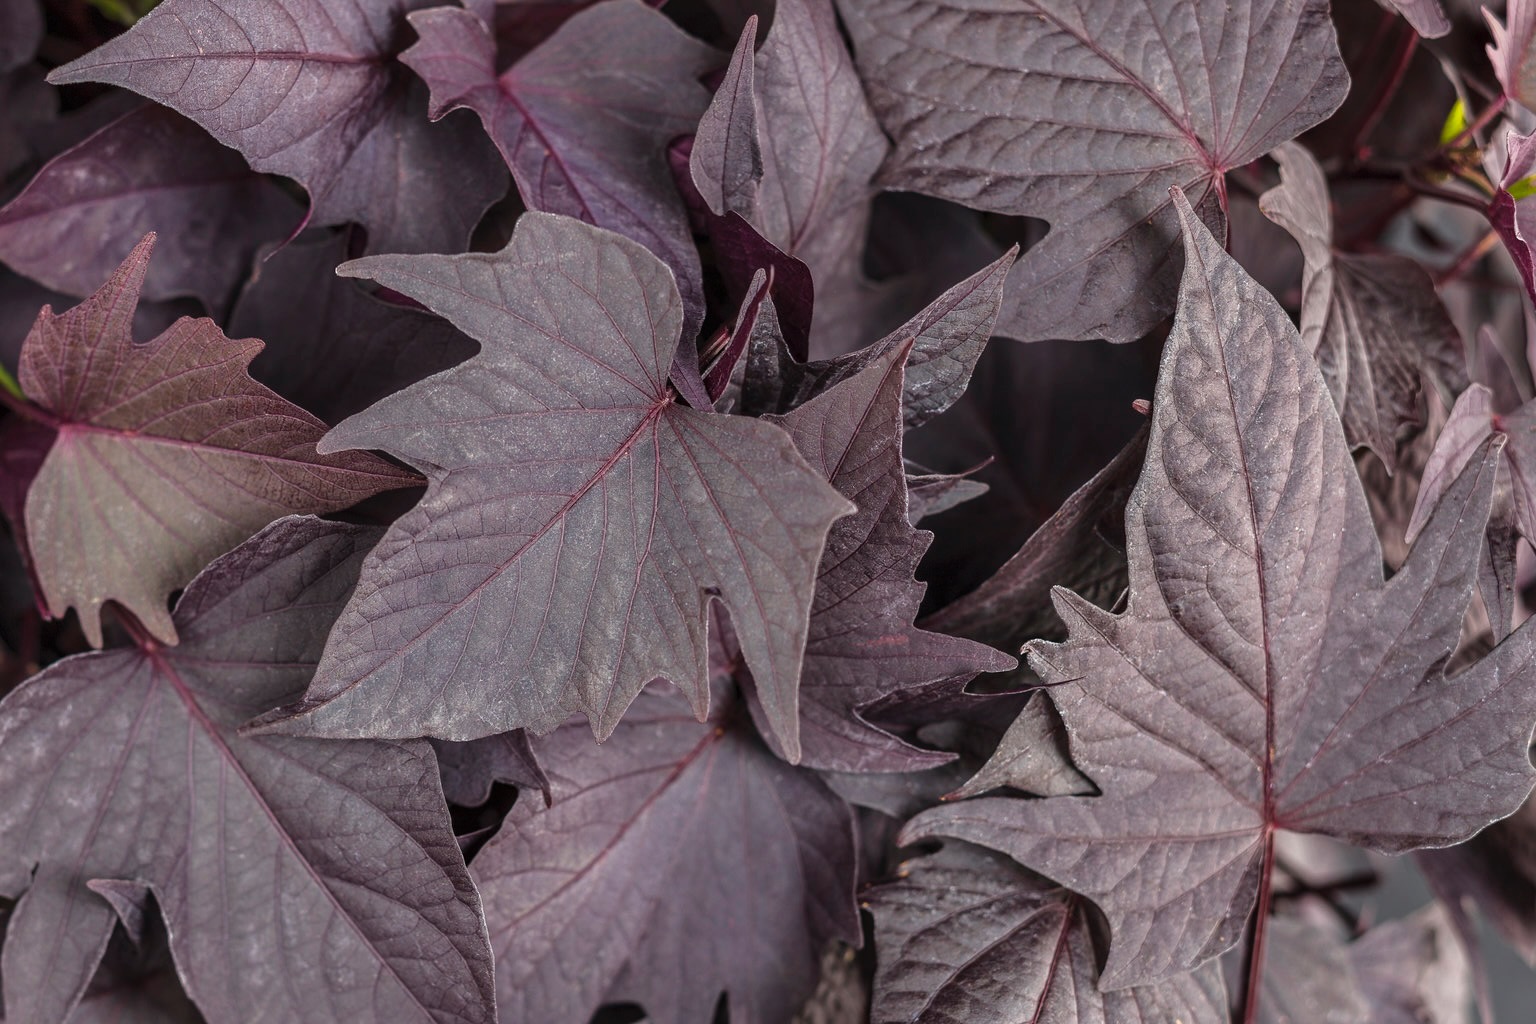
[865,843,1227,1024]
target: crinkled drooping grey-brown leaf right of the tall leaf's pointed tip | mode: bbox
[1260,143,1467,470]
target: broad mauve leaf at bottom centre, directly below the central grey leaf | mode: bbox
[470,666,860,1024]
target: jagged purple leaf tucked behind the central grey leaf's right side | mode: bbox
[737,342,1014,772]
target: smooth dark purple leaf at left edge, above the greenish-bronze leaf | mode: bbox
[0,103,303,310]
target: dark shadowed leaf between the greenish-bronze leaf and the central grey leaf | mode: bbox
[229,233,476,424]
